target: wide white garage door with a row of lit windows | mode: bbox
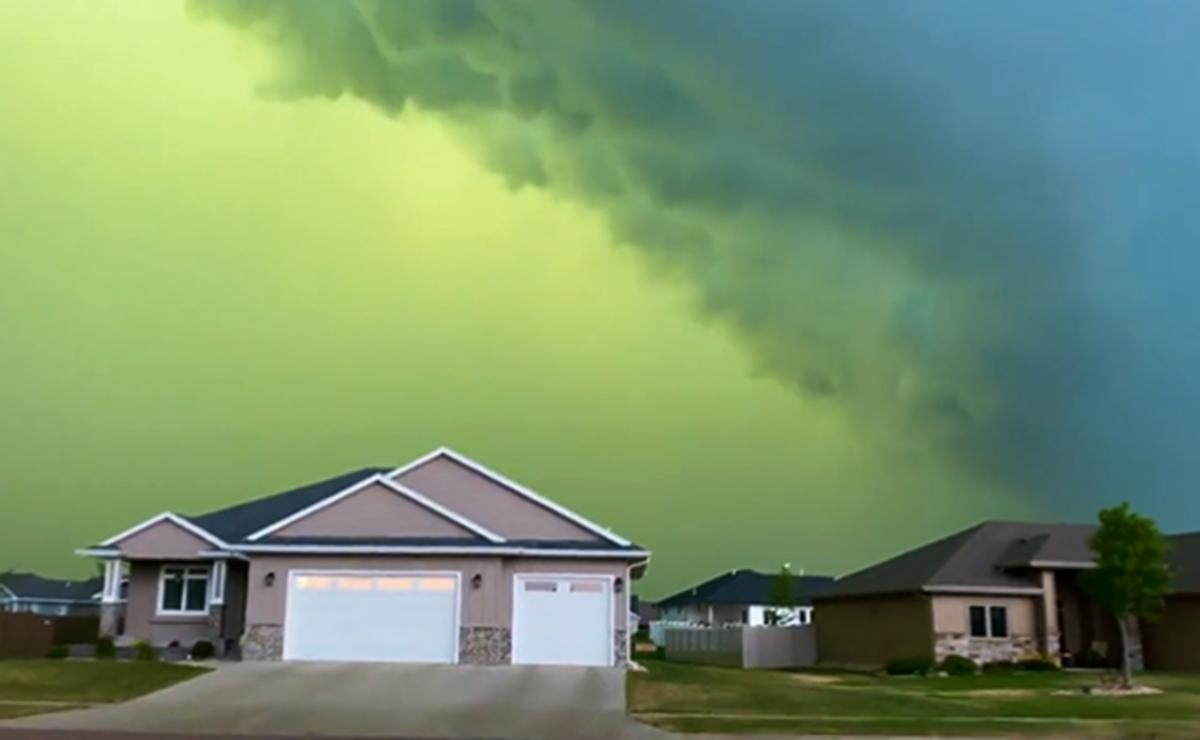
[283,571,460,663]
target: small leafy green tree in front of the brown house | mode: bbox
[1082,503,1171,688]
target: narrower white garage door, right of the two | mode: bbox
[512,574,613,666]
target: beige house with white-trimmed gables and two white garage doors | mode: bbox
[78,449,650,666]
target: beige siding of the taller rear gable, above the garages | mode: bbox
[396,457,600,541]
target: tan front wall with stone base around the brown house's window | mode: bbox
[932,595,1040,663]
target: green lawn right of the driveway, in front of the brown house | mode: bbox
[629,660,1200,738]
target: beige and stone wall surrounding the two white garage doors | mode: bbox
[242,555,630,663]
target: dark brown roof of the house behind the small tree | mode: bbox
[827,522,1200,597]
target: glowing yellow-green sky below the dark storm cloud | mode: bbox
[0,0,1022,594]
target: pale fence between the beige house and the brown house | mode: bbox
[652,625,817,668]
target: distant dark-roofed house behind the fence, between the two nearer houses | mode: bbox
[656,568,834,626]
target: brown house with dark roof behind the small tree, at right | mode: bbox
[814,522,1200,669]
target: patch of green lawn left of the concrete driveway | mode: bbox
[0,660,208,711]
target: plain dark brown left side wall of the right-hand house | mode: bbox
[812,594,934,668]
